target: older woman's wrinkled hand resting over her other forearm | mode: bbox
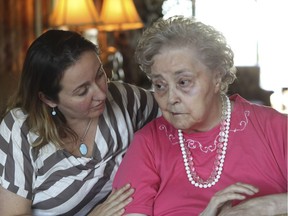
[200,183,258,216]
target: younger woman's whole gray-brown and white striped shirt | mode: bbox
[0,82,158,216]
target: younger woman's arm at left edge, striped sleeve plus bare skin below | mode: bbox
[0,111,33,216]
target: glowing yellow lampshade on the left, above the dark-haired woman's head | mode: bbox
[49,0,100,29]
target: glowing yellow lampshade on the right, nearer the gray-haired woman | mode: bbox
[99,0,143,31]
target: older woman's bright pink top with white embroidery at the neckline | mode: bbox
[114,95,287,216]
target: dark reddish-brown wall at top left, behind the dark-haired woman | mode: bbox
[0,0,50,113]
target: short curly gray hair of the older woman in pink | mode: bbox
[135,16,236,92]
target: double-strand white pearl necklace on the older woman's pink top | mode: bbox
[178,95,231,188]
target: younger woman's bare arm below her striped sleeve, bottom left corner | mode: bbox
[0,186,32,216]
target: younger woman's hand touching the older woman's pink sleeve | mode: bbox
[89,184,134,216]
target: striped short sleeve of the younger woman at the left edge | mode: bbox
[0,112,33,199]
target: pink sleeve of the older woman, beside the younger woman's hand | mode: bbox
[113,131,160,215]
